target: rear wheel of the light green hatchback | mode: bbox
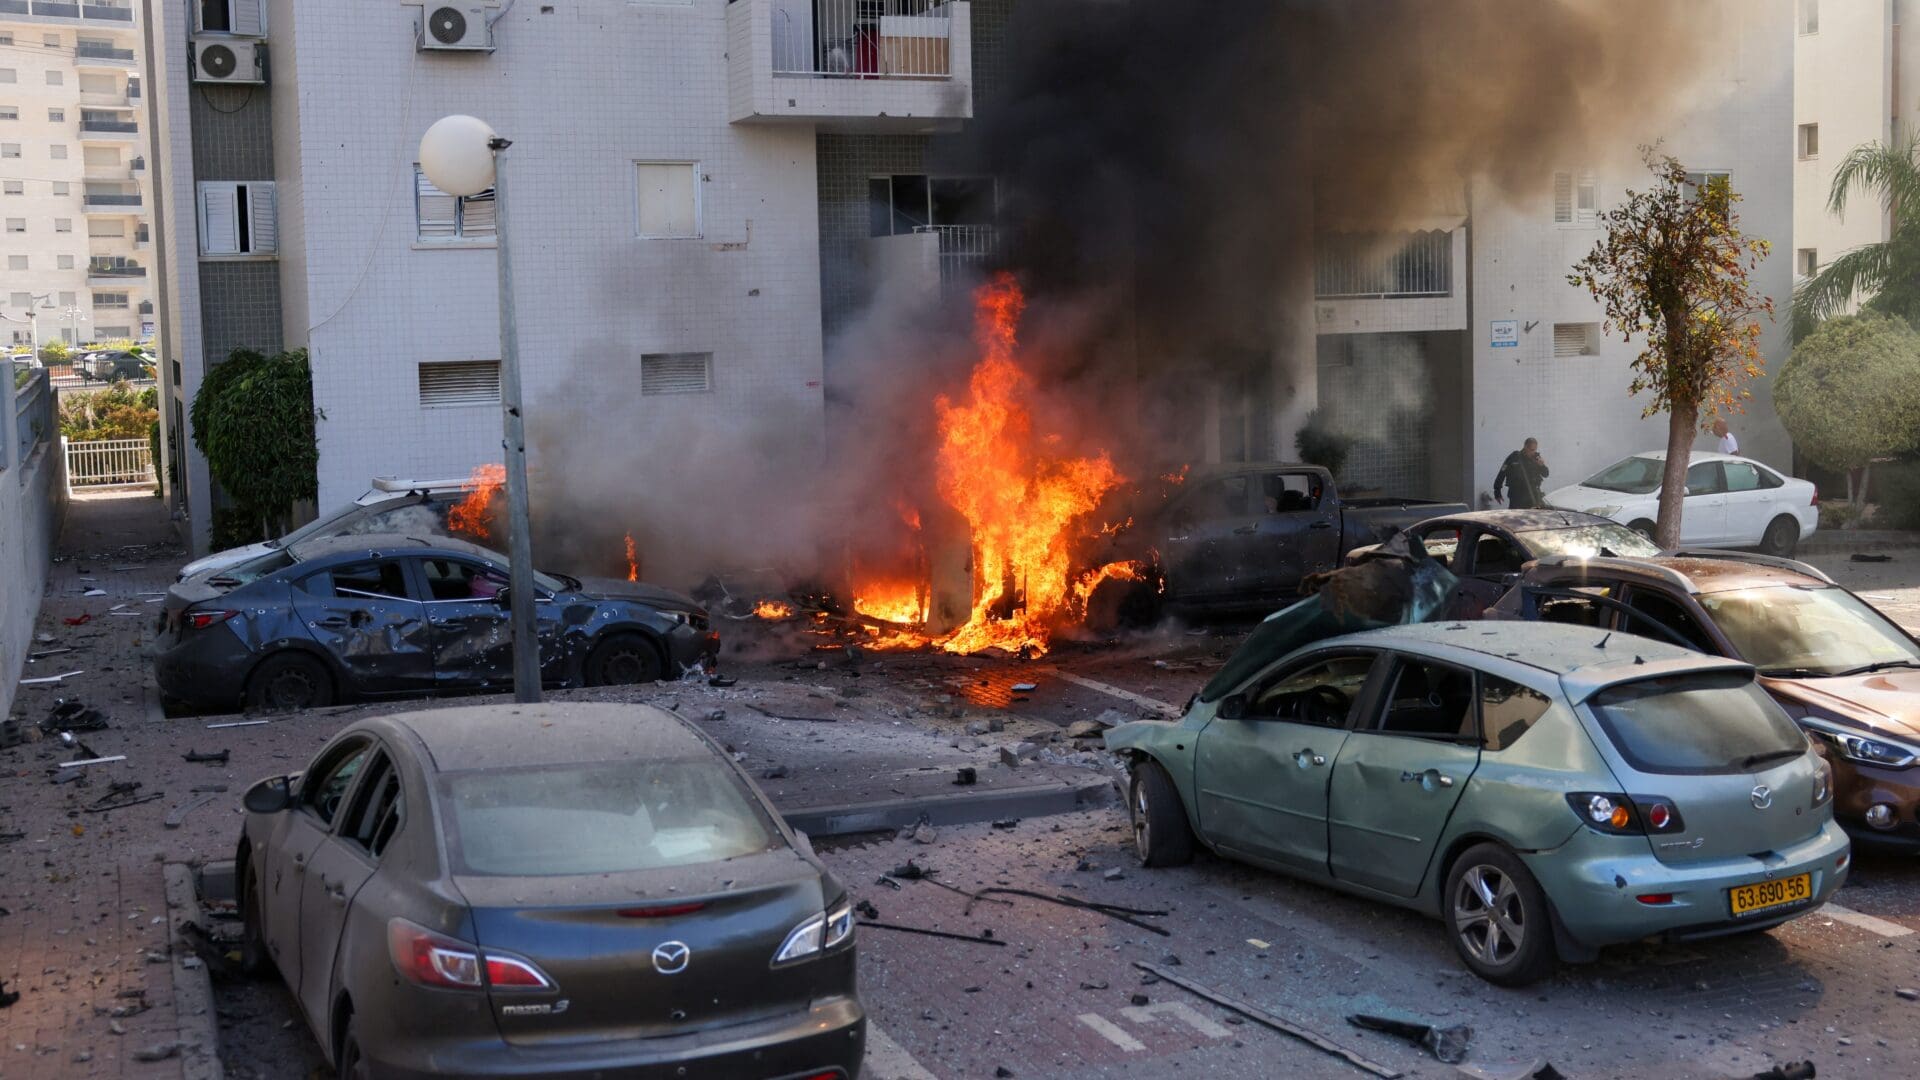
[1440,844,1559,986]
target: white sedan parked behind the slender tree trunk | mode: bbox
[1548,452,1820,555]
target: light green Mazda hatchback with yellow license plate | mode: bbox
[1106,617,1849,986]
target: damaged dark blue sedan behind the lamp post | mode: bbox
[154,534,720,709]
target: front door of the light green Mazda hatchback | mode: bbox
[1194,650,1379,872]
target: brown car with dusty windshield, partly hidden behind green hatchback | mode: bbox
[1488,550,1920,851]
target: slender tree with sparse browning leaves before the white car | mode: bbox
[1567,150,1774,548]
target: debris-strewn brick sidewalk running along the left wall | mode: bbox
[0,492,219,1080]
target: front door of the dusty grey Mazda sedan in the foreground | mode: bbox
[259,734,372,988]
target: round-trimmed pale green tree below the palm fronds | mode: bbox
[1774,311,1920,507]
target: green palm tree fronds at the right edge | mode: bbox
[1793,129,1920,342]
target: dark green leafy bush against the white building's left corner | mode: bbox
[190,350,324,536]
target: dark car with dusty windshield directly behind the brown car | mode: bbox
[1346,509,1661,584]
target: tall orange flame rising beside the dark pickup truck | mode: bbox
[935,273,1123,655]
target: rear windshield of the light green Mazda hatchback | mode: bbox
[1588,673,1807,774]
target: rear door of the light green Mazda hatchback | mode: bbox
[1327,655,1480,896]
